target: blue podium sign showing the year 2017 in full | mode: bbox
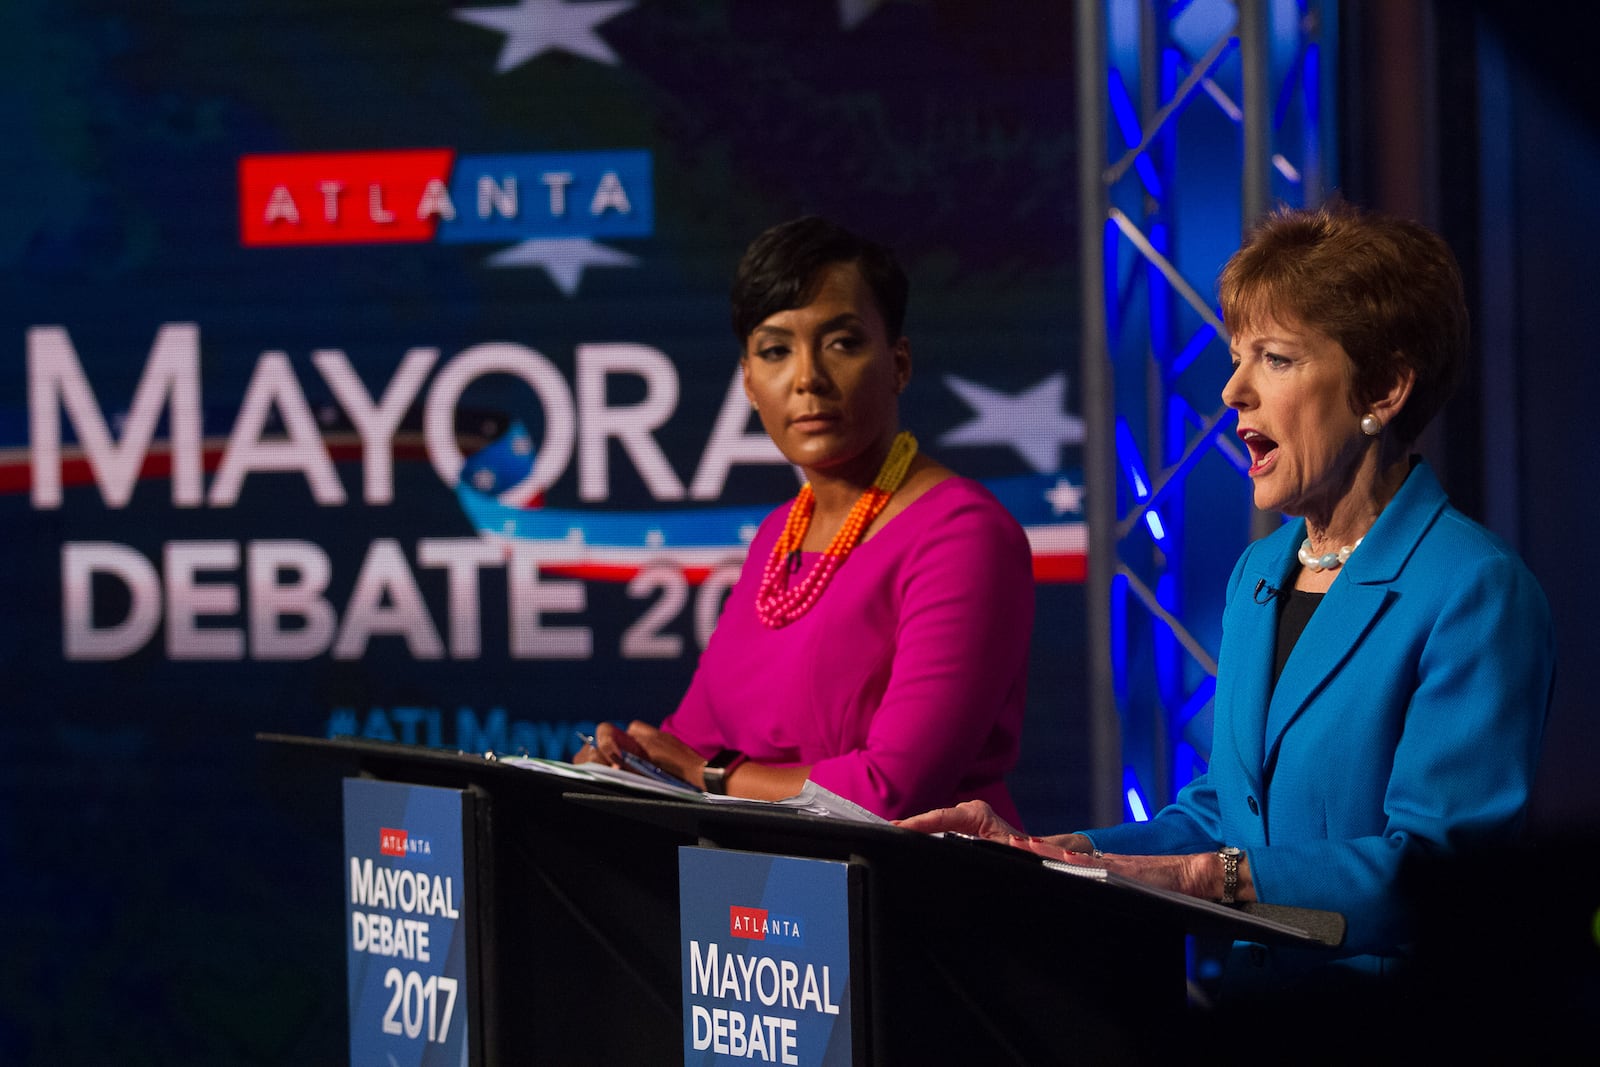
[344,777,480,1067]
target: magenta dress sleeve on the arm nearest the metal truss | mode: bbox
[811,498,1034,817]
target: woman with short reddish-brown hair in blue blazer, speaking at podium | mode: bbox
[901,205,1555,995]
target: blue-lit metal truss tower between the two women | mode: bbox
[1075,0,1334,825]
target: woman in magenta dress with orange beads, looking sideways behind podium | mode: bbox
[578,218,1034,819]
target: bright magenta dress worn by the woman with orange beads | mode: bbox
[662,478,1034,825]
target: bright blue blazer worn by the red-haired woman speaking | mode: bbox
[1090,461,1555,984]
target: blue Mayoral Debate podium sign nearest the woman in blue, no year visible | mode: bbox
[678,846,866,1067]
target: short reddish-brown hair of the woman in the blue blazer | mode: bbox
[1218,202,1470,446]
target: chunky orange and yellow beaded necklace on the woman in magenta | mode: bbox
[755,430,917,630]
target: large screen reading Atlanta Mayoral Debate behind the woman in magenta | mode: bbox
[0,0,1090,1064]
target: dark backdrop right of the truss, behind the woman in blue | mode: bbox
[1342,0,1600,838]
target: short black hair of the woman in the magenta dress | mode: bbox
[731,214,910,347]
